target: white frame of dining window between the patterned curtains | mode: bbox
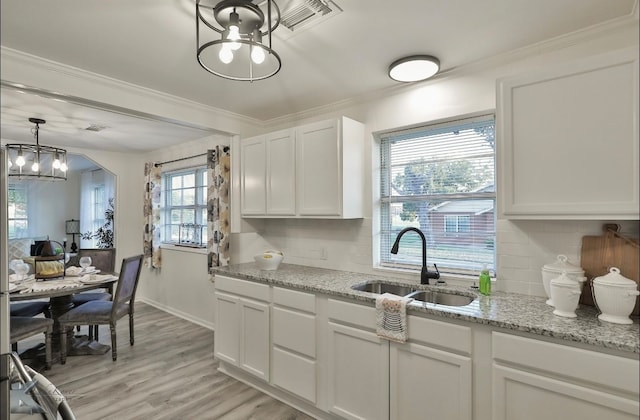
[160,165,208,247]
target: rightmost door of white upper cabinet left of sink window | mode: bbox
[296,120,342,216]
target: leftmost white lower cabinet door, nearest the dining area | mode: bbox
[213,292,240,366]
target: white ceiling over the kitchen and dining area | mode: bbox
[0,0,637,151]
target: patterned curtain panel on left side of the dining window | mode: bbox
[143,162,162,268]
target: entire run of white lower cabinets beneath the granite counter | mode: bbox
[214,275,640,420]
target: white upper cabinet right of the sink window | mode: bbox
[497,48,640,220]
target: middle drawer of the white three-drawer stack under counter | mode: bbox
[271,306,316,358]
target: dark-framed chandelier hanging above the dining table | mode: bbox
[6,118,67,180]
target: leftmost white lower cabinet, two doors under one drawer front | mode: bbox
[214,276,270,381]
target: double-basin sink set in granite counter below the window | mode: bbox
[352,281,475,306]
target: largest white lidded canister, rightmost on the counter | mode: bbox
[593,267,640,324]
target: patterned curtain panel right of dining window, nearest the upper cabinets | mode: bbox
[207,146,231,275]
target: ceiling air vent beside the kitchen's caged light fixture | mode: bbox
[280,0,342,31]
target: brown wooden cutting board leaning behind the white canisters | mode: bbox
[580,224,640,316]
